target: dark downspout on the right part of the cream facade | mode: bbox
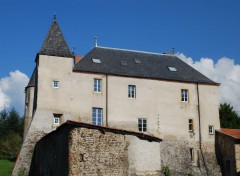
[197,82,209,176]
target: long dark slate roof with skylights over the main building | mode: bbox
[74,46,219,85]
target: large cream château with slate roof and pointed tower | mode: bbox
[13,15,220,175]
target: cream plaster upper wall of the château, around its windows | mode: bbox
[34,56,220,142]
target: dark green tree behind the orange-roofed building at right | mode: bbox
[219,103,240,129]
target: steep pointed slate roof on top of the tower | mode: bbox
[39,15,73,57]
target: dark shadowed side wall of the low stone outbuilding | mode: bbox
[29,128,70,176]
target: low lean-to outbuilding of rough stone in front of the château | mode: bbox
[29,121,161,176]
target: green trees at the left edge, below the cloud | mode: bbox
[0,108,23,160]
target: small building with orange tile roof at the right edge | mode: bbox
[216,128,240,176]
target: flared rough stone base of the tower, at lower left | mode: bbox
[12,131,45,176]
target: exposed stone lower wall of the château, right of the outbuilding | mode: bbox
[160,141,221,176]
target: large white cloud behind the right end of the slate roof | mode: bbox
[177,53,240,114]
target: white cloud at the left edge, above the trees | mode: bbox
[0,70,29,115]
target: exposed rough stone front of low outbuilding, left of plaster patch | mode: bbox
[69,128,128,176]
